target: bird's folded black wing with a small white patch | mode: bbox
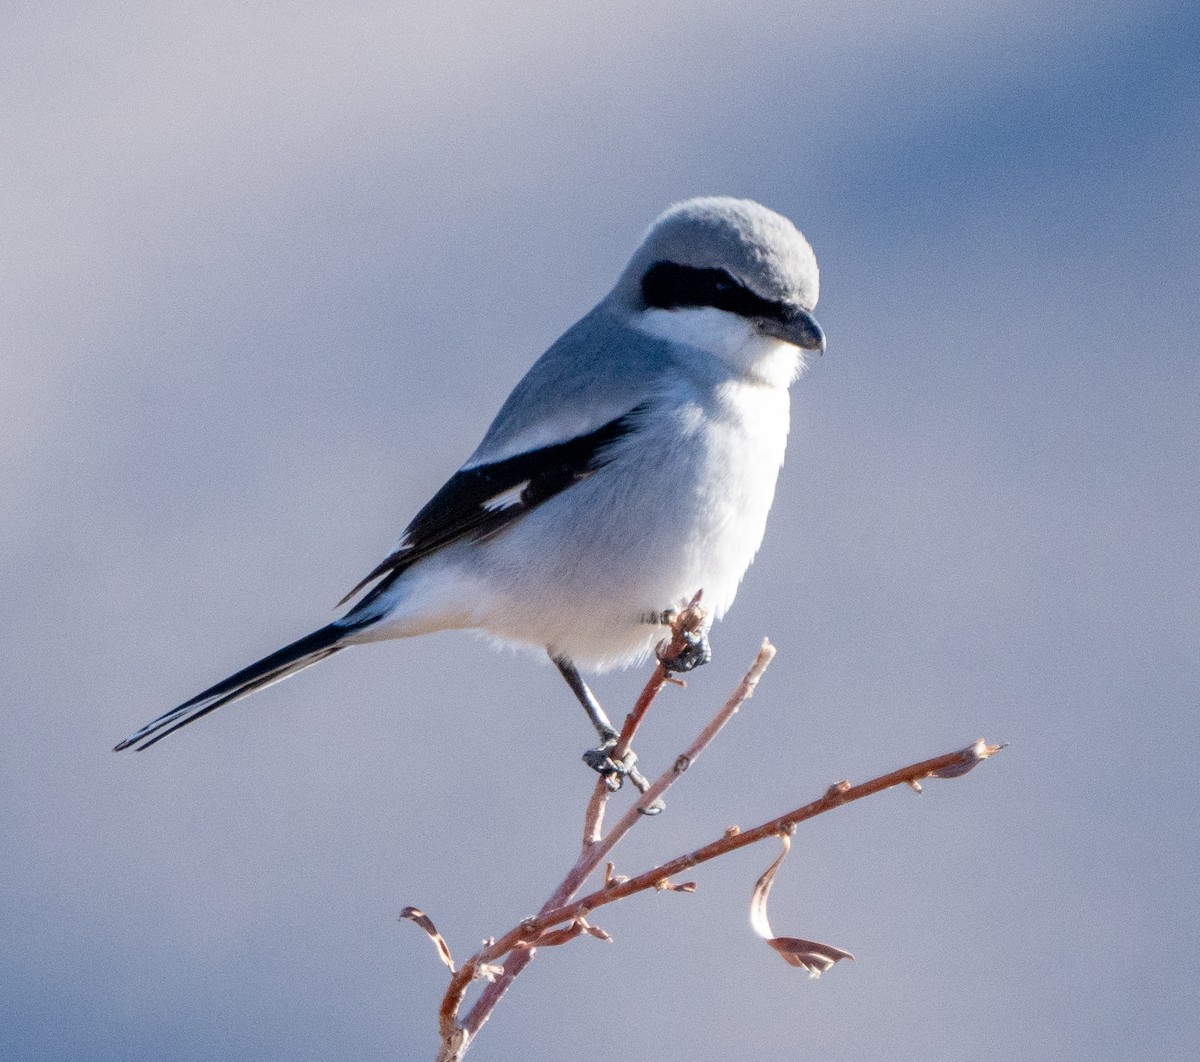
[338,407,641,607]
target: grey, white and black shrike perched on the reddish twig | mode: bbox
[116,197,824,772]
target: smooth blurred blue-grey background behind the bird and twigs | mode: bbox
[0,0,1200,1062]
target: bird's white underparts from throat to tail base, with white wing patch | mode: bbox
[360,310,799,668]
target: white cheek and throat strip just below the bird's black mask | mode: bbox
[632,306,804,388]
